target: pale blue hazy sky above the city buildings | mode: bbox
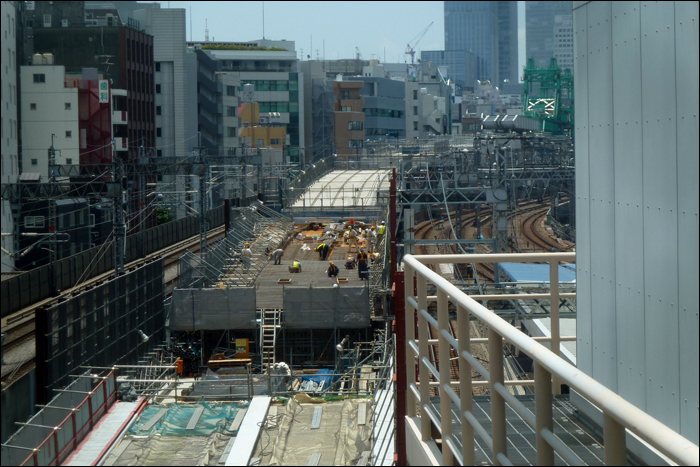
[158,1,525,77]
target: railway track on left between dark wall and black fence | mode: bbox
[2,227,224,385]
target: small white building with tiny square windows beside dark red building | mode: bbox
[20,65,80,181]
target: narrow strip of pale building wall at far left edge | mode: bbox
[0,2,19,272]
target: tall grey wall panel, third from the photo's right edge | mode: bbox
[612,2,646,409]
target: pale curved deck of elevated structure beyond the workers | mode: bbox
[292,170,389,217]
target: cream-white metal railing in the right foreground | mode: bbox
[403,253,699,465]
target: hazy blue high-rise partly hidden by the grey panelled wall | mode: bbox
[525,1,574,68]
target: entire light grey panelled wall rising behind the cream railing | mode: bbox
[574,2,699,443]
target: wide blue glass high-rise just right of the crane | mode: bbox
[442,1,518,87]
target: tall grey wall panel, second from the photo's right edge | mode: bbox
[639,3,680,430]
